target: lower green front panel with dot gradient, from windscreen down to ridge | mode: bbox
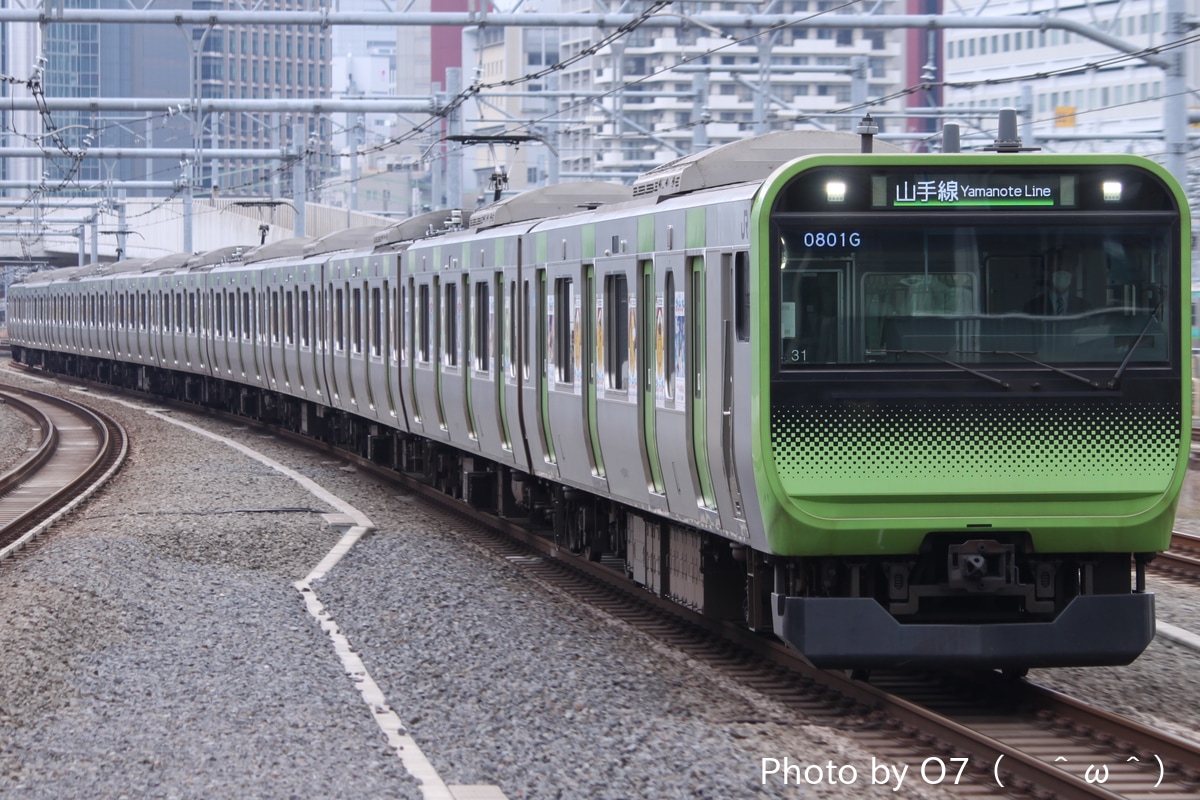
[770,401,1182,500]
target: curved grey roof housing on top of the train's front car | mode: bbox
[634,131,904,199]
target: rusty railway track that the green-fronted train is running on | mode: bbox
[11,367,1200,800]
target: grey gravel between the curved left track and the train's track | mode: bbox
[0,376,964,800]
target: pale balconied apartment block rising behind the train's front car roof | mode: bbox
[463,0,904,186]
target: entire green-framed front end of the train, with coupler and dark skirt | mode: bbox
[754,156,1190,669]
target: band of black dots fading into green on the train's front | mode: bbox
[770,403,1181,488]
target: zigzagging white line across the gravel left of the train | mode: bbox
[138,409,475,800]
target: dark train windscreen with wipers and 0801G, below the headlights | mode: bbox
[772,215,1178,369]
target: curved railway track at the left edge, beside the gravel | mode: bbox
[0,386,127,560]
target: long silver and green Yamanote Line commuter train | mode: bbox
[10,132,1190,670]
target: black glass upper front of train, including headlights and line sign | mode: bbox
[772,167,1178,369]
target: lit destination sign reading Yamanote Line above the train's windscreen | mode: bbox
[871,173,1076,211]
